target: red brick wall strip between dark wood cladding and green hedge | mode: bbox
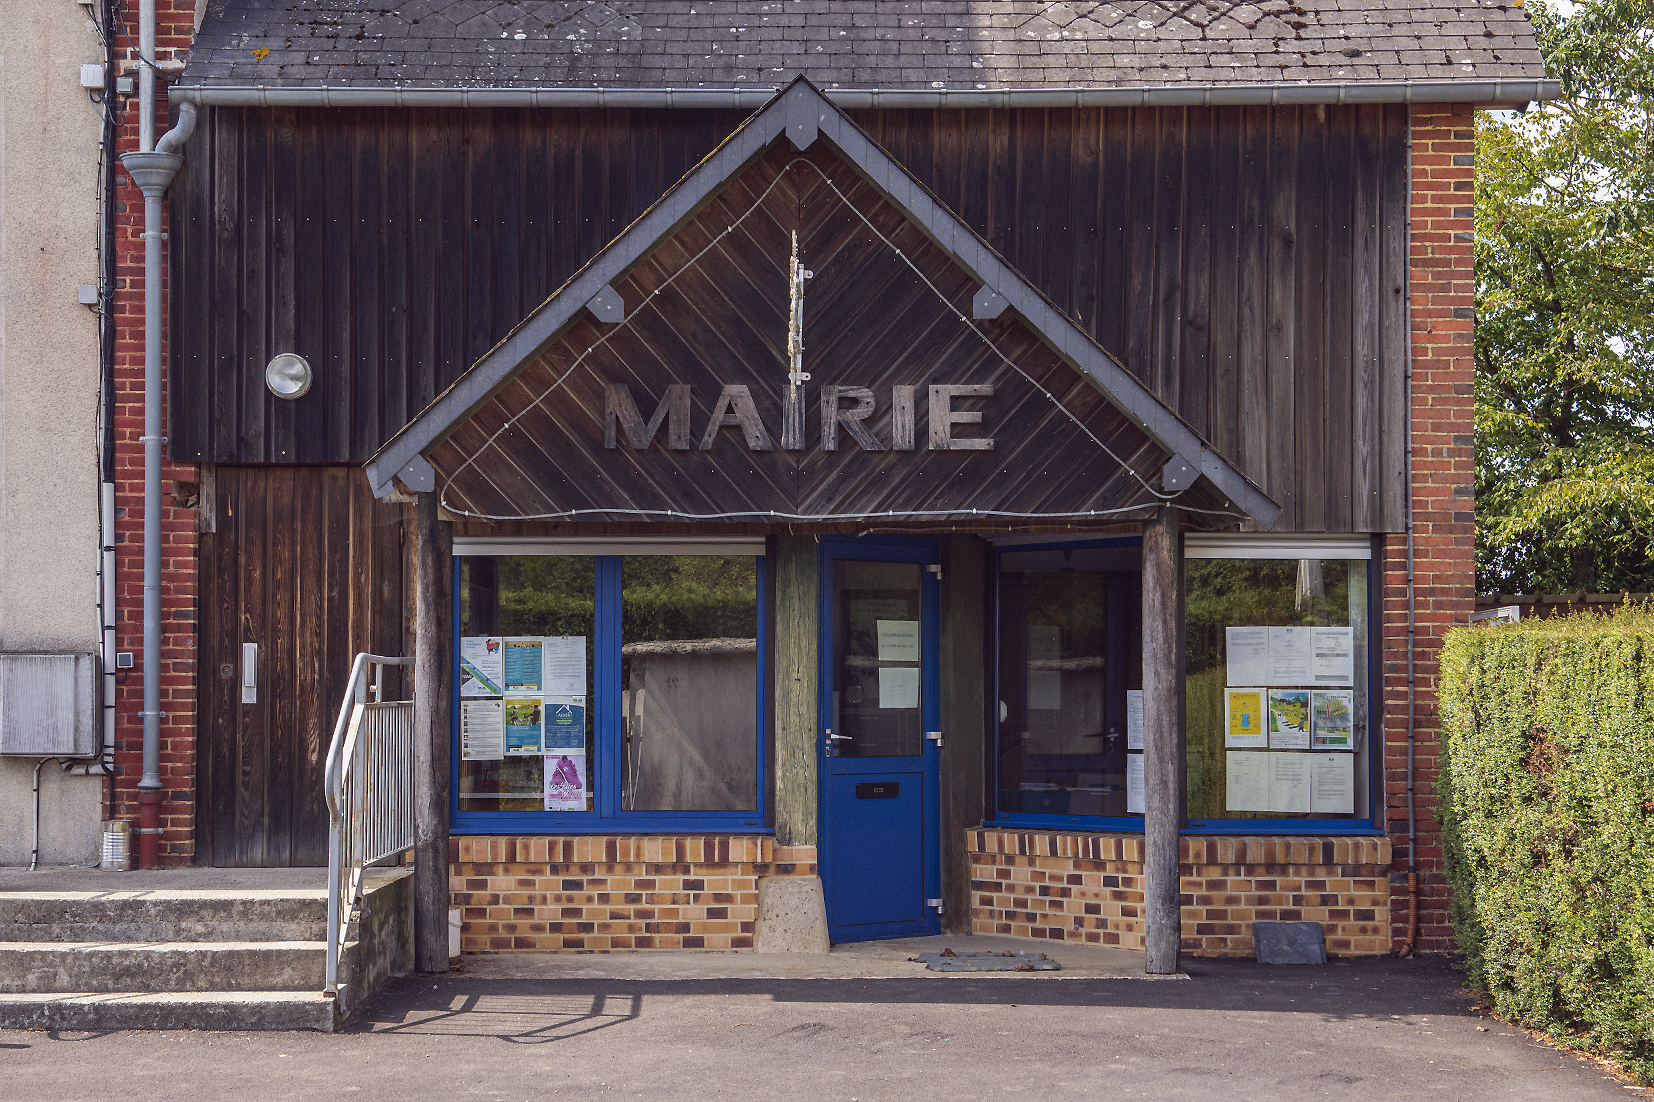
[1383,104,1475,951]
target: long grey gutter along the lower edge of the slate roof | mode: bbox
[167,79,1561,109]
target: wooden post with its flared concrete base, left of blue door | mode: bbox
[753,536,827,953]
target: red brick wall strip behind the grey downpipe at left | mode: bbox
[112,0,198,864]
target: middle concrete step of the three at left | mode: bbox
[0,941,327,994]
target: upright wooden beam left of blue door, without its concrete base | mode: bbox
[774,536,820,846]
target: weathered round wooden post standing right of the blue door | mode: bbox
[1143,505,1183,975]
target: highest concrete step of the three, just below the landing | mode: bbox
[0,889,327,941]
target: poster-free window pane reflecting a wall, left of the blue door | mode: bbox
[620,556,758,811]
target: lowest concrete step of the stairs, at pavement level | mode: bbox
[0,991,337,1033]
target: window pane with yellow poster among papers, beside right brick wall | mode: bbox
[1184,559,1371,819]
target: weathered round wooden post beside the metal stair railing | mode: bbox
[414,493,453,971]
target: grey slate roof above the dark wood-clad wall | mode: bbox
[182,0,1545,91]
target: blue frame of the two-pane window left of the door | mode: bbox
[450,543,769,834]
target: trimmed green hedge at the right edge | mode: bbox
[1437,606,1654,1082]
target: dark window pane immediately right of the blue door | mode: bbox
[997,546,1143,816]
